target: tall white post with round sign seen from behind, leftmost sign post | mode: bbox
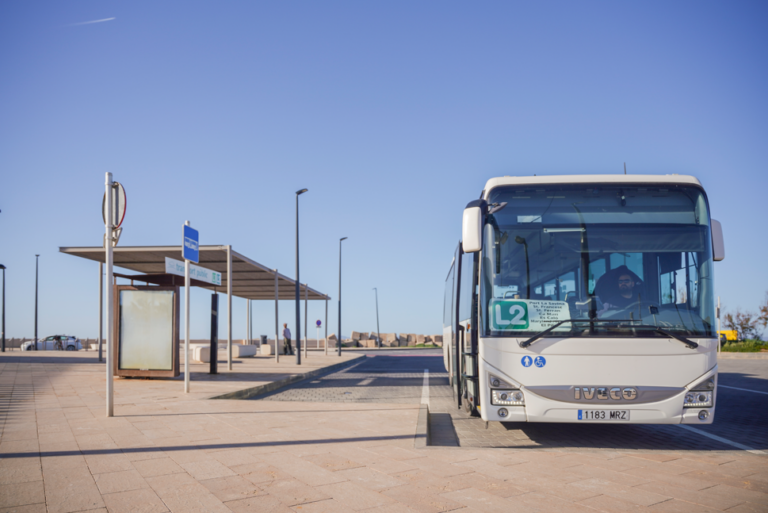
[101,173,127,417]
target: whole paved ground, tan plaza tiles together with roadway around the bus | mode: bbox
[0,351,768,512]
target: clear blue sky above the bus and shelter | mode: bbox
[0,1,768,338]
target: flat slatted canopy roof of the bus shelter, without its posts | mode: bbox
[59,246,330,300]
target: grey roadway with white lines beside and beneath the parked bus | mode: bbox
[257,350,768,451]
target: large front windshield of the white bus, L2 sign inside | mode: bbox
[480,184,715,337]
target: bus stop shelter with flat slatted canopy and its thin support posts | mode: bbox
[59,245,330,370]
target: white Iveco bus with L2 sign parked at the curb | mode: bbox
[443,175,724,424]
